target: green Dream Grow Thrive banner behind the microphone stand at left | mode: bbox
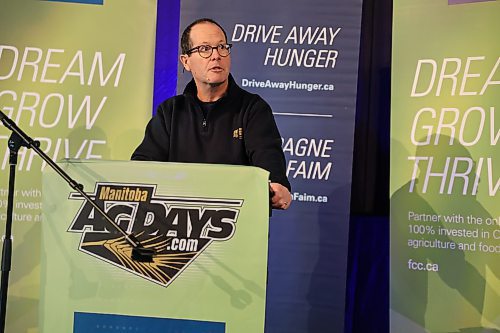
[0,0,156,333]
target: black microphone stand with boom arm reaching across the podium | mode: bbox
[0,110,155,333]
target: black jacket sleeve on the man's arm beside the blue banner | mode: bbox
[243,97,291,190]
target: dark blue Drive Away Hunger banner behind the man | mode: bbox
[172,0,362,333]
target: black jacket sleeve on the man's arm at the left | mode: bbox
[132,104,170,162]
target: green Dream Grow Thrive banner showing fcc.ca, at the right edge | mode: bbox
[390,0,500,333]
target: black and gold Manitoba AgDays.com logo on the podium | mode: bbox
[68,183,243,287]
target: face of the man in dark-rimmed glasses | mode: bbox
[181,22,231,87]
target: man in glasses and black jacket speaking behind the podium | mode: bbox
[132,18,292,209]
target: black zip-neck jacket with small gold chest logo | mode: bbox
[132,75,290,190]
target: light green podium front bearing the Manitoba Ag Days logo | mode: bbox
[40,161,269,333]
